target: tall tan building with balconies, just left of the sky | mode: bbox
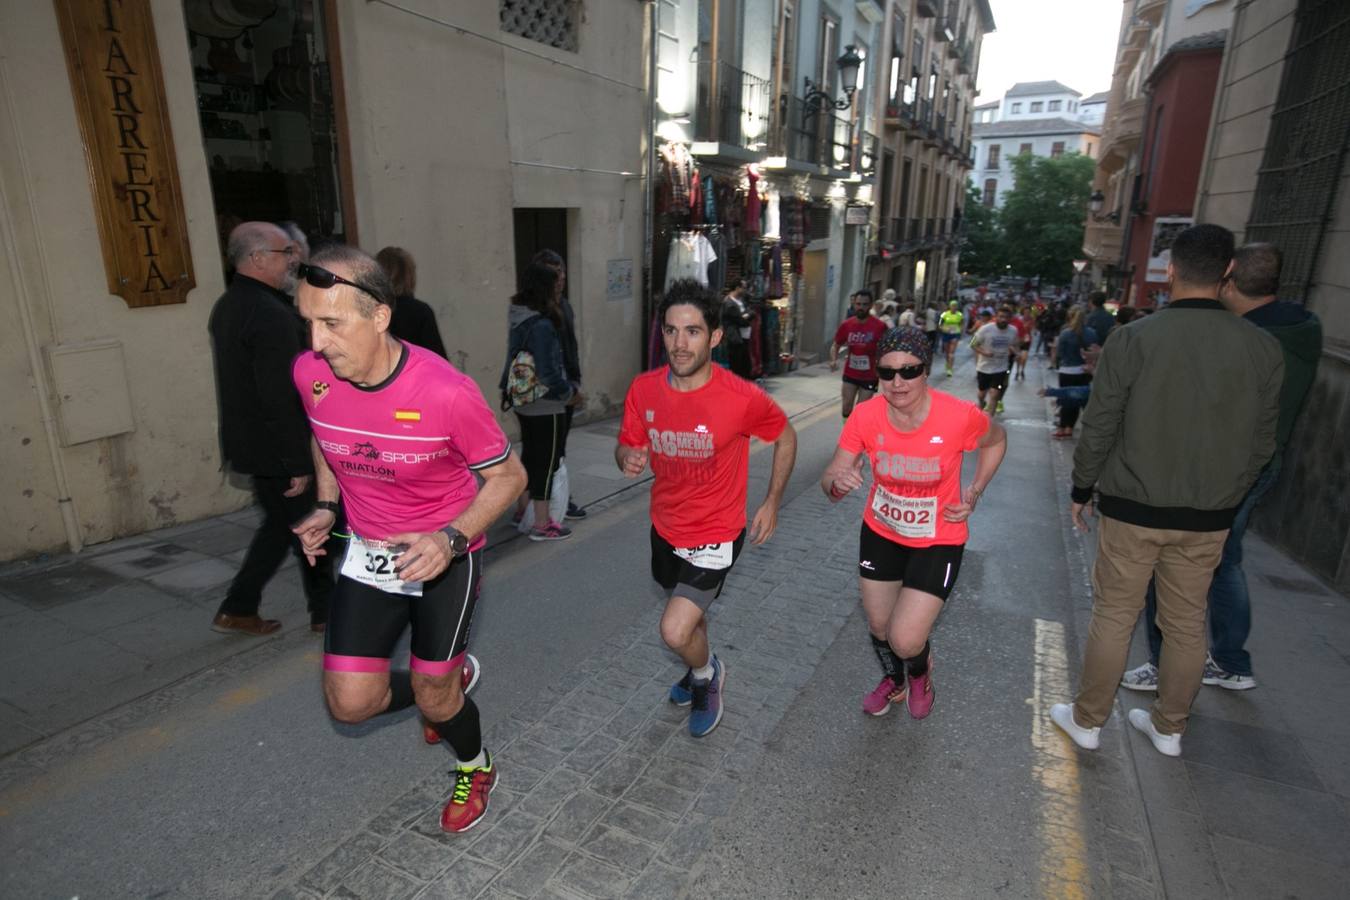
[868,0,995,309]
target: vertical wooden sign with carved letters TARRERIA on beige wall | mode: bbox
[55,0,196,308]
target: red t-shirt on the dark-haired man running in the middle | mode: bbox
[618,366,787,546]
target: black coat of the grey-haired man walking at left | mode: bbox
[209,274,315,478]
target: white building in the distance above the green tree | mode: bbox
[971,81,1102,206]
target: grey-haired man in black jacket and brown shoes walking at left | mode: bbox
[209,221,332,636]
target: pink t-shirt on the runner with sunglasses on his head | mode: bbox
[292,343,510,549]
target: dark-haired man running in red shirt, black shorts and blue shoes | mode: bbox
[614,279,797,738]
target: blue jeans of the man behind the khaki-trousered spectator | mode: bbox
[1143,463,1280,675]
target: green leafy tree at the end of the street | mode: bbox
[999,152,1096,285]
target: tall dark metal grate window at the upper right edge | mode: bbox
[1246,0,1350,302]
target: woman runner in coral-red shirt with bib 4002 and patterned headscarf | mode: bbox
[821,327,1007,719]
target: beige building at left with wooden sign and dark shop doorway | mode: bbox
[0,0,651,559]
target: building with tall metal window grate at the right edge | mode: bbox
[1195,0,1350,594]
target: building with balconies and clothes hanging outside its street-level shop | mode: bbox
[648,0,887,374]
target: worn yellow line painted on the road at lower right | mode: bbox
[1031,619,1091,900]
